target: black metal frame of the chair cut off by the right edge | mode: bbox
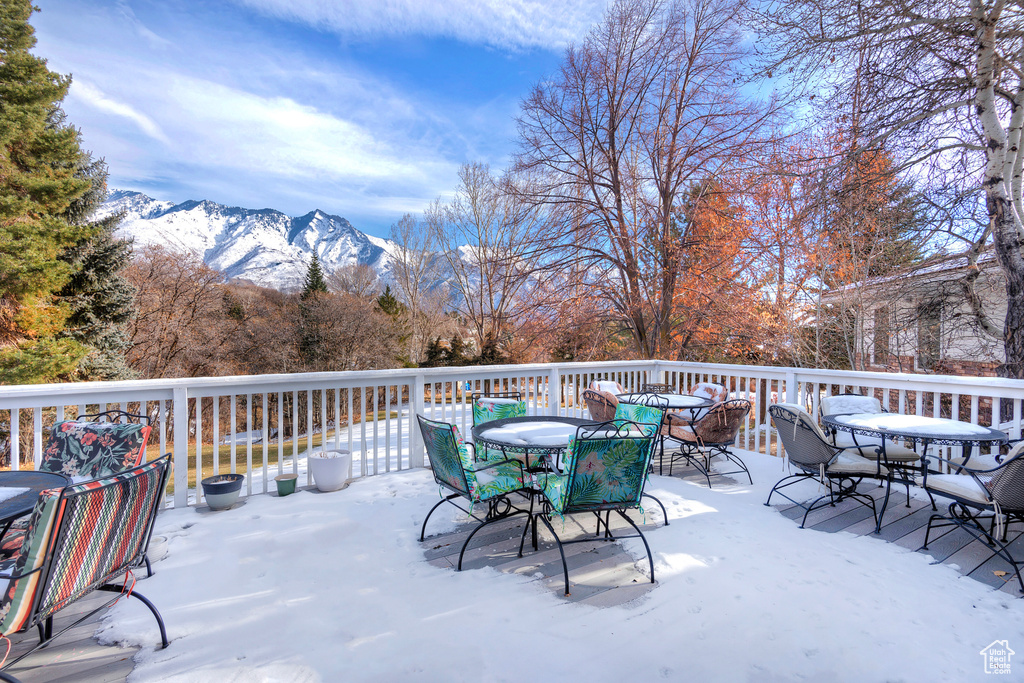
[921,451,1024,593]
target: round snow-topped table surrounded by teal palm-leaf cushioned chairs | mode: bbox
[473,415,601,470]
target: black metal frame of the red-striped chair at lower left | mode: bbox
[0,454,171,683]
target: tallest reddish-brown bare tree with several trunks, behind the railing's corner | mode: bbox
[517,0,773,357]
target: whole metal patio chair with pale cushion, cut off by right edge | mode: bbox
[921,441,1024,593]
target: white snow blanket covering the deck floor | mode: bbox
[105,454,1024,683]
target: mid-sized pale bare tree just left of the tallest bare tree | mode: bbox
[424,164,547,350]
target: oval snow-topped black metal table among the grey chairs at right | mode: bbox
[821,413,1009,532]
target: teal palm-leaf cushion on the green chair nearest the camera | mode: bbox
[539,438,653,514]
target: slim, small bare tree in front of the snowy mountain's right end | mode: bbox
[391,213,454,362]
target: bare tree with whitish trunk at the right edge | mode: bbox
[754,0,1024,378]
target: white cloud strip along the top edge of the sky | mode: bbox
[234,0,605,48]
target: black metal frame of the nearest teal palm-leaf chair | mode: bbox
[519,420,668,595]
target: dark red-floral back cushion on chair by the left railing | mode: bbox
[39,421,153,479]
